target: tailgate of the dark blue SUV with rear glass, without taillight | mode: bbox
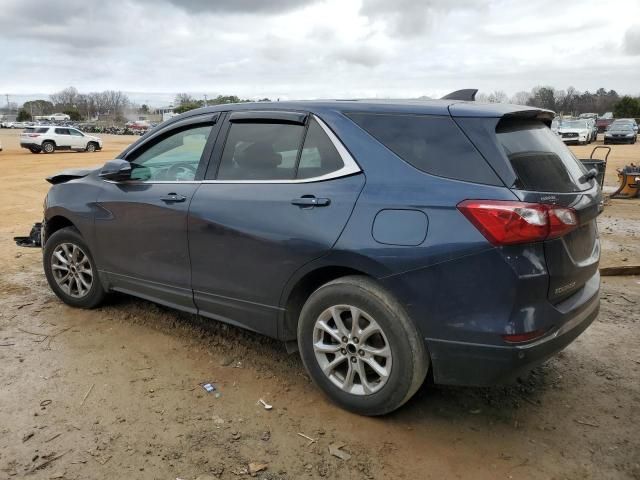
[456,111,602,303]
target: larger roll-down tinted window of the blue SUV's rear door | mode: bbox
[217,123,304,180]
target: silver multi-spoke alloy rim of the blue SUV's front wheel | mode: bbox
[51,243,93,298]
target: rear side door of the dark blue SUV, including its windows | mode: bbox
[189,111,365,336]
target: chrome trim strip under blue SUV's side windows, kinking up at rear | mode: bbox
[104,114,362,185]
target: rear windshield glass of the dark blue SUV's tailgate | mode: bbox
[496,119,591,193]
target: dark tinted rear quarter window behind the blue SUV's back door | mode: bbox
[347,113,500,185]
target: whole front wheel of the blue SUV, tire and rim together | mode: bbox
[43,227,106,308]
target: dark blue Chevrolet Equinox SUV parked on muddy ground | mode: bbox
[43,100,602,415]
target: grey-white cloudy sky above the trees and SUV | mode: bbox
[0,0,640,103]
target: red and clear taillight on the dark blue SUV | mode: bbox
[458,200,578,245]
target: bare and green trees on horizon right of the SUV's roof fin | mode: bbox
[476,86,640,117]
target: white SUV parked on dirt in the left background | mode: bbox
[20,126,102,153]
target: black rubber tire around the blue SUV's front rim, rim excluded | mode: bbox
[42,227,106,308]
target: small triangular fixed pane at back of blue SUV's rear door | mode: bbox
[296,119,344,178]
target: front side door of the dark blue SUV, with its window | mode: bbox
[95,114,217,311]
